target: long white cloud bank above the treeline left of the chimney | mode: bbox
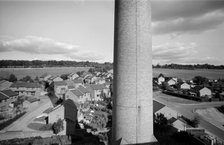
[0,36,104,61]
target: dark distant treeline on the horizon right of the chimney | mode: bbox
[153,64,224,69]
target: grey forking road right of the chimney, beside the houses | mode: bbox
[153,92,224,141]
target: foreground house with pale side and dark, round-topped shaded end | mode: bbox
[46,99,78,135]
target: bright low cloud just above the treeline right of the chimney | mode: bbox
[153,42,223,64]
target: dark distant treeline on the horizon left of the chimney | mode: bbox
[0,60,113,70]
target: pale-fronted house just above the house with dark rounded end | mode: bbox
[54,81,68,99]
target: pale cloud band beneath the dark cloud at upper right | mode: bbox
[152,10,224,35]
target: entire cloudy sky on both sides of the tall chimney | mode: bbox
[0,0,224,65]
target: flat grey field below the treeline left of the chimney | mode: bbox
[0,67,90,79]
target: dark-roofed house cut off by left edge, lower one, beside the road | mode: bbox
[0,90,18,112]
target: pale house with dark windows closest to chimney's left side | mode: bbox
[86,84,109,101]
